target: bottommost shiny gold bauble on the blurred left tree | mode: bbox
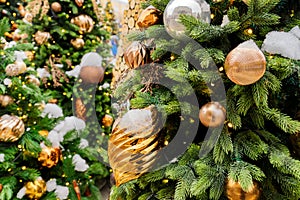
[25,179,46,200]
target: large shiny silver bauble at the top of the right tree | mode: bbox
[164,0,211,39]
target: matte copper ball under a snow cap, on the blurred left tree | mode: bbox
[79,66,104,83]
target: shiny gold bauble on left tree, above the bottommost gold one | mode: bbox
[38,147,61,168]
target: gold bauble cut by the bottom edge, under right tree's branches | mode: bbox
[226,179,261,200]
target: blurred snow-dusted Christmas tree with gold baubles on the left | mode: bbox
[0,1,113,200]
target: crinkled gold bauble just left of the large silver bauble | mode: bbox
[137,6,162,28]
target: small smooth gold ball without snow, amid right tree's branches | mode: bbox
[199,102,226,127]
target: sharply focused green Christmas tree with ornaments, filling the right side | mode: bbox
[108,0,300,200]
